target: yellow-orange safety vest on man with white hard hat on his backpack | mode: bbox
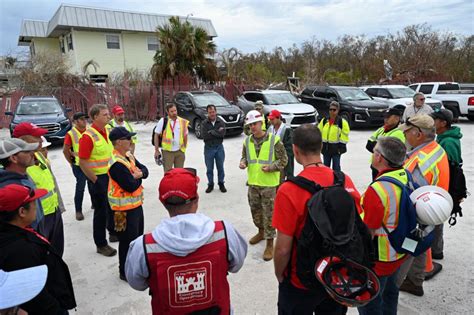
[361,169,408,262]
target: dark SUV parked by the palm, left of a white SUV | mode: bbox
[173,91,245,139]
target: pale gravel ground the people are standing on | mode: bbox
[0,120,474,314]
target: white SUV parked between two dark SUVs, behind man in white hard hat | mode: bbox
[237,90,318,128]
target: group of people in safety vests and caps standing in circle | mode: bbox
[0,89,462,314]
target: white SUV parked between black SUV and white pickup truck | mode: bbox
[361,85,443,112]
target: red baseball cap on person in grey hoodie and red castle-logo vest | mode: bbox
[158,168,199,205]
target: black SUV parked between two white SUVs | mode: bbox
[300,85,389,127]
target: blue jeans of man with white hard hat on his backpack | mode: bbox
[357,269,400,315]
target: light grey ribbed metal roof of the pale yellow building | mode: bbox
[18,4,217,45]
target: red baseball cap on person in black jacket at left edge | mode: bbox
[0,184,48,212]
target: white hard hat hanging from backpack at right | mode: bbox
[410,185,453,225]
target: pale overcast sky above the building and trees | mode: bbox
[0,0,474,55]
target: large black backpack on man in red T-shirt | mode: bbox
[288,171,375,290]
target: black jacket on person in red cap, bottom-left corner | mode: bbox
[0,221,76,315]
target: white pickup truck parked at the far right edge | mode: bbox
[409,82,474,121]
